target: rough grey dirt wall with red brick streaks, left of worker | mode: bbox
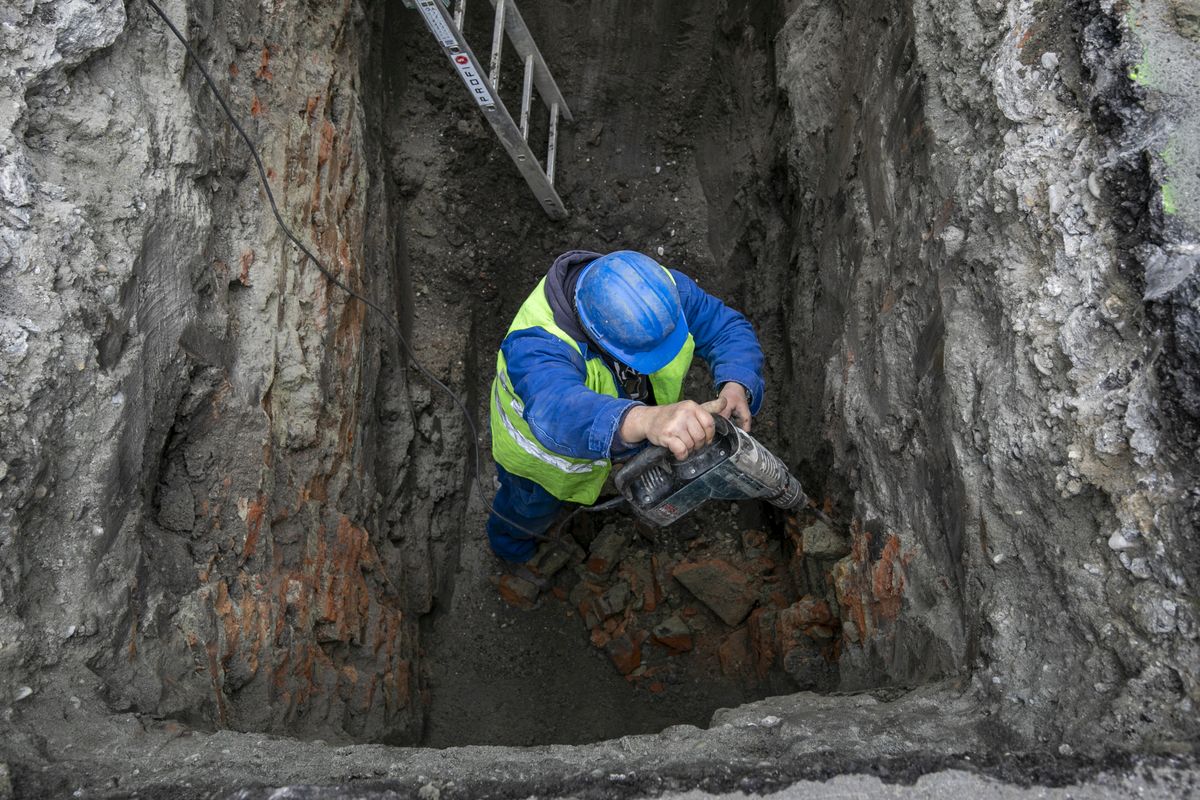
[0,2,432,739]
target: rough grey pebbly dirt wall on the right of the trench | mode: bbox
[707,2,1198,747]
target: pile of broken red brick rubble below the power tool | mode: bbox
[498,515,857,693]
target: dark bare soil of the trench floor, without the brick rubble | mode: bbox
[394,2,830,746]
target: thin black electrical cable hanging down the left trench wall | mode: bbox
[145,0,571,542]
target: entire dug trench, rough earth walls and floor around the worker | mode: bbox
[0,0,1200,796]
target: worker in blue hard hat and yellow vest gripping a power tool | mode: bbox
[487,251,763,564]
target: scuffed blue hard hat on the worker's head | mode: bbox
[575,249,688,374]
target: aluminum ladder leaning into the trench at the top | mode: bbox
[404,0,572,219]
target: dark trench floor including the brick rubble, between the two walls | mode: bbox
[384,2,926,746]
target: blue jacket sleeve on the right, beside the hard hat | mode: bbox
[671,270,764,414]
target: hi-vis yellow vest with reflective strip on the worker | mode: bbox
[491,272,696,505]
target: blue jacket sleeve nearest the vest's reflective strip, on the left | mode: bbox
[500,327,642,458]
